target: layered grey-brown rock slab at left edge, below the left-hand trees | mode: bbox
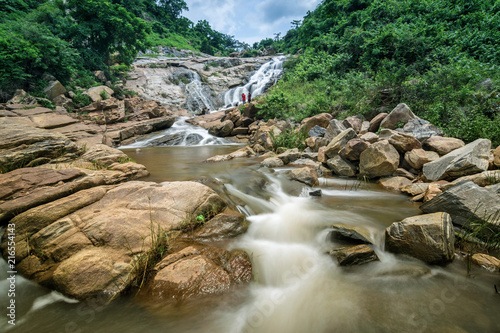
[0,124,80,172]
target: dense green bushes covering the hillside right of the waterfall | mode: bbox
[254,0,500,145]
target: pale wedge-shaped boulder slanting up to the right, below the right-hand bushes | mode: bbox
[423,139,491,180]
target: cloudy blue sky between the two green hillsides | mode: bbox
[182,0,321,45]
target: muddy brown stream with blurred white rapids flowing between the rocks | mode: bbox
[0,125,500,333]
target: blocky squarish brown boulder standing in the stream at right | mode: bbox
[385,213,455,265]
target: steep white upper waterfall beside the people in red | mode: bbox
[224,56,285,108]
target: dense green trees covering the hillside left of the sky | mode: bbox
[0,0,240,101]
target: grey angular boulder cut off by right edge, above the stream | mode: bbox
[420,181,500,230]
